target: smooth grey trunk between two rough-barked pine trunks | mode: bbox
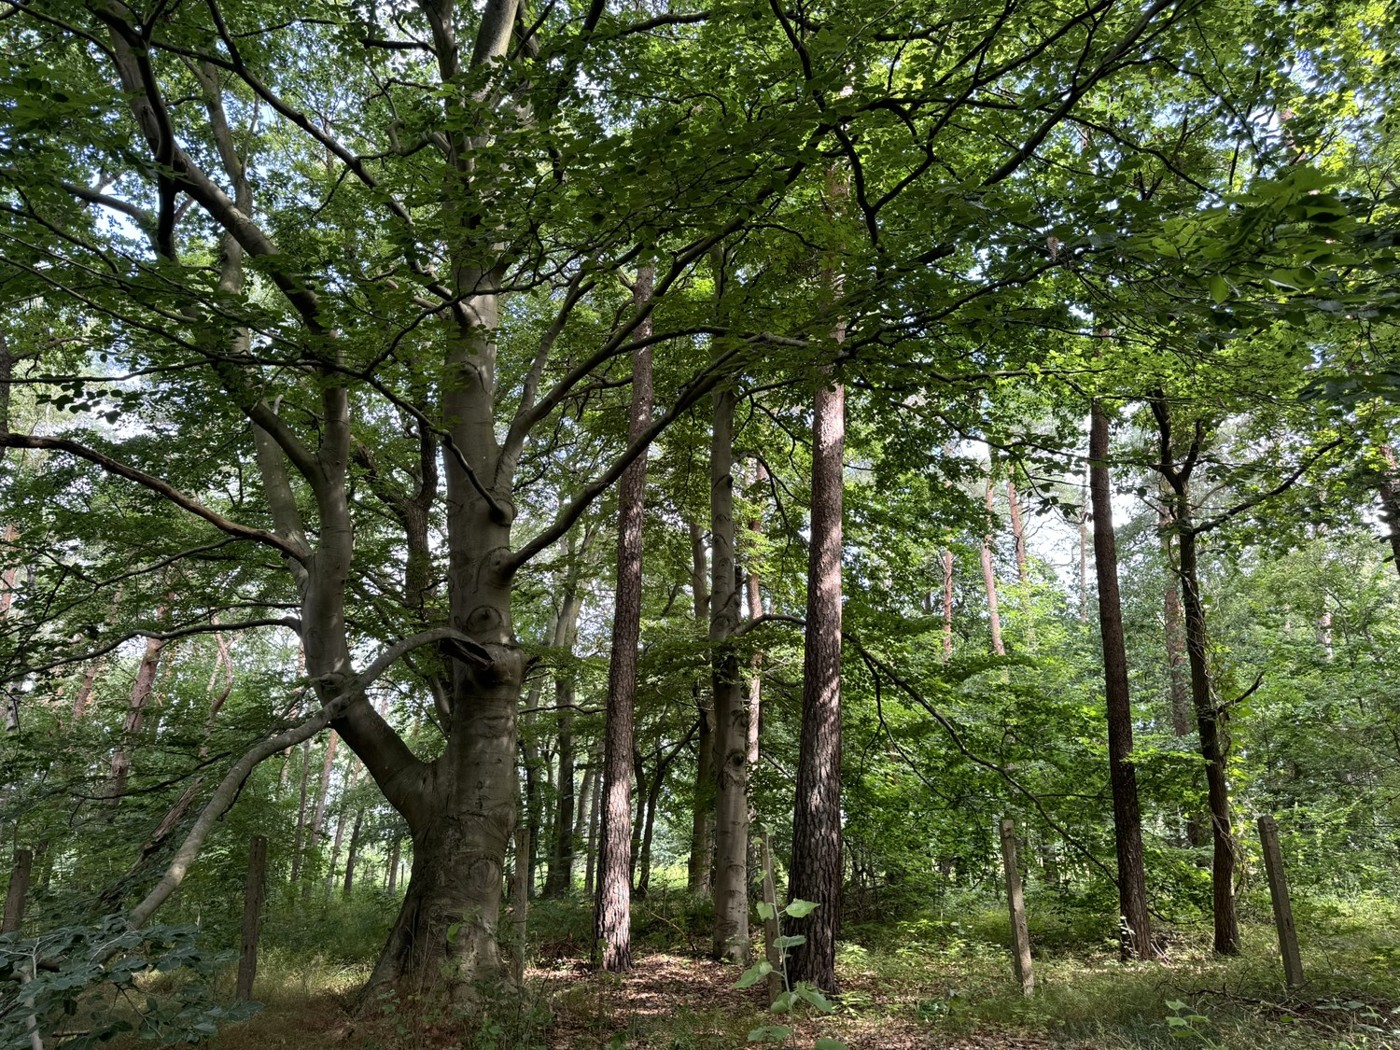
[710,388,749,962]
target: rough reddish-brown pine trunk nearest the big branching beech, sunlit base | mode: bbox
[594,267,652,973]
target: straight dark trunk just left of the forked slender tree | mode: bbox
[1089,399,1154,959]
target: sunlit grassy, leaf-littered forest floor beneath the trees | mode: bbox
[203,907,1400,1050]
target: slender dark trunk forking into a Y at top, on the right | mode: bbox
[1152,395,1239,955]
